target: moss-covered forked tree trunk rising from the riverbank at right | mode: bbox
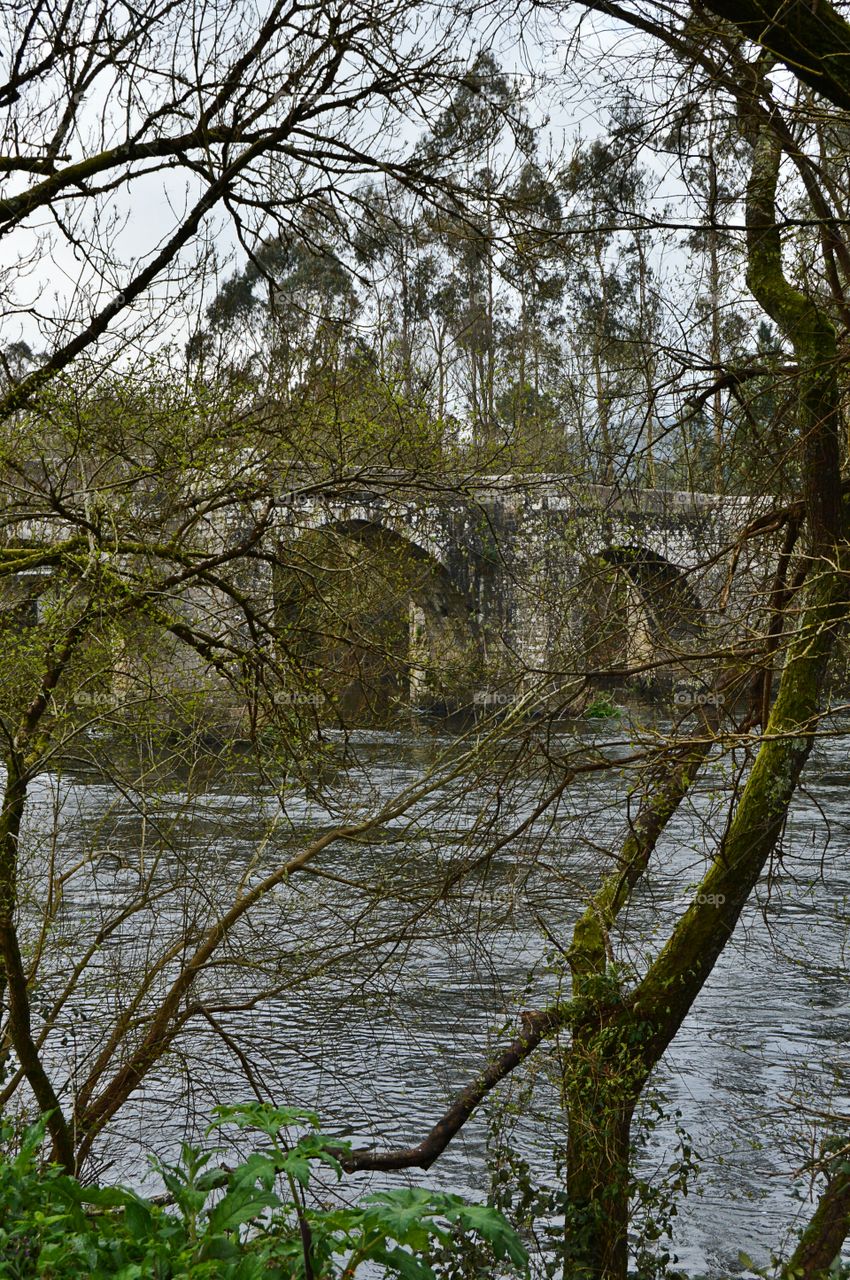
[565,117,850,1280]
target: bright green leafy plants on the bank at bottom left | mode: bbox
[0,1103,527,1280]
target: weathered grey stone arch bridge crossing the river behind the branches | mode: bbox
[4,468,776,718]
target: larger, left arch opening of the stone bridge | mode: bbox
[274,513,481,721]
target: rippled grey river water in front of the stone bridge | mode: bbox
[16,727,850,1274]
